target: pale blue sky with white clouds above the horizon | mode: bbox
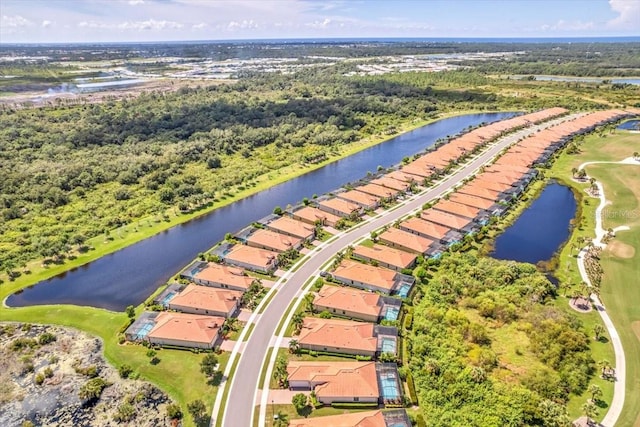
[0,0,640,43]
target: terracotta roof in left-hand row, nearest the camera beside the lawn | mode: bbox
[147,311,224,344]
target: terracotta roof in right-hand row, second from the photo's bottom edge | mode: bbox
[287,361,380,401]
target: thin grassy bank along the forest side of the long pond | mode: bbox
[0,110,506,300]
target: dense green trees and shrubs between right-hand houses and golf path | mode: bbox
[403,254,595,426]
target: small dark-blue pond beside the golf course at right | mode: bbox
[491,181,577,264]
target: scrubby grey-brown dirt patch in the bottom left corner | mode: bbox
[0,323,171,427]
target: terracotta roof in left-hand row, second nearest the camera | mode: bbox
[169,285,242,313]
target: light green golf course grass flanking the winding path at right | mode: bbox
[551,131,640,427]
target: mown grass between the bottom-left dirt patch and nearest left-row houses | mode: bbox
[0,305,229,426]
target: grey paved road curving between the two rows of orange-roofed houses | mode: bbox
[219,115,575,427]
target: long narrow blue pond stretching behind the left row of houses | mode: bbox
[6,113,514,311]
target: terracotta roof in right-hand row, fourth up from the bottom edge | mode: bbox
[313,285,382,316]
